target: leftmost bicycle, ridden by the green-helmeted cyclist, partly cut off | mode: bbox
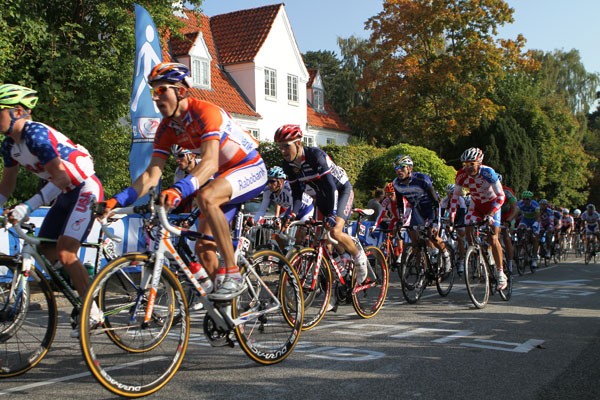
[0,217,116,378]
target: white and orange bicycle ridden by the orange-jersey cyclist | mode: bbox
[80,196,304,397]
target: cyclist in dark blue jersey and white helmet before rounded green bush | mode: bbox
[392,154,452,272]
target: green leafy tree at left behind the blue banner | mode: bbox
[0,0,201,200]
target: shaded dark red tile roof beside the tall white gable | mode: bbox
[210,3,283,65]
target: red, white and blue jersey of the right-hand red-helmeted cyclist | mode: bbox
[450,165,505,214]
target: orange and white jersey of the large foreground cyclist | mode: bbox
[152,97,260,176]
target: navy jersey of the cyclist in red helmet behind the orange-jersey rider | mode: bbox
[283,147,352,215]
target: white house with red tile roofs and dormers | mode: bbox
[163,4,351,146]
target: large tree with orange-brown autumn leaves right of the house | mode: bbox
[353,0,533,151]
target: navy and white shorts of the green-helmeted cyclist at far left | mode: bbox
[38,175,104,242]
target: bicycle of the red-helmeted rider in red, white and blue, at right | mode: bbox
[465,222,513,308]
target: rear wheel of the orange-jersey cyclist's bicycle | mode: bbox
[231,250,304,365]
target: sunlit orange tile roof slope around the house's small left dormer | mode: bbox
[163,12,260,118]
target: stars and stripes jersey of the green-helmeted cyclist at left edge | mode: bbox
[0,121,95,191]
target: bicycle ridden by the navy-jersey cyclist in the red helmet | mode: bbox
[290,209,389,330]
